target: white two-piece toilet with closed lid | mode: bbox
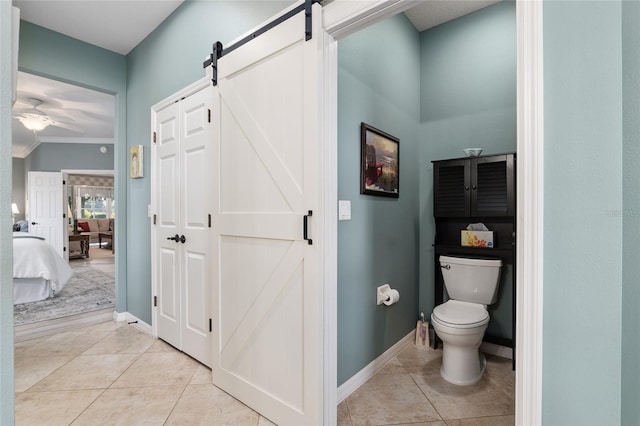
[431,256,502,385]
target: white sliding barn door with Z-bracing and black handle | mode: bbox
[212,5,323,425]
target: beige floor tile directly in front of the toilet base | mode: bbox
[411,373,515,420]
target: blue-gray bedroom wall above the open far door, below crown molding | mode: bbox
[25,143,114,172]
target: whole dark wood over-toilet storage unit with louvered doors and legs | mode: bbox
[433,154,516,365]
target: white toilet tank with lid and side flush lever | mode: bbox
[440,256,502,305]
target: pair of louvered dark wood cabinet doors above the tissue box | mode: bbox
[433,154,515,217]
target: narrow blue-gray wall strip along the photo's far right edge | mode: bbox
[621,0,640,425]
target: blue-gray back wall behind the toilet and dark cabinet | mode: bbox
[416,1,516,338]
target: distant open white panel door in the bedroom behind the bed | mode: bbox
[28,172,66,258]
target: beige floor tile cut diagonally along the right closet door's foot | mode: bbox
[112,352,199,388]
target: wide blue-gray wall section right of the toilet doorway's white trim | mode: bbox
[542,1,624,425]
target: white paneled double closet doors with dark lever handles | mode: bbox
[154,87,217,365]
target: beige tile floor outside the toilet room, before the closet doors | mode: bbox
[15,322,272,426]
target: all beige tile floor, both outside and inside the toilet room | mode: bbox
[15,322,515,426]
